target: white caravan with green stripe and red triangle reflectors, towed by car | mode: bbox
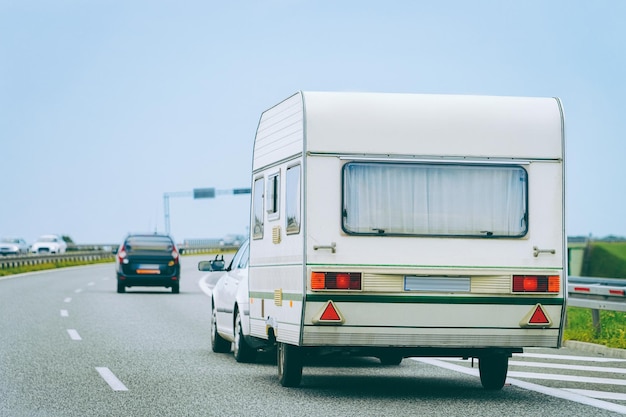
[249,92,567,390]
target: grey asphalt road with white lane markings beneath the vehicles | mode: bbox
[0,256,626,417]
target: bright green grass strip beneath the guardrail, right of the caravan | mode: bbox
[564,307,626,349]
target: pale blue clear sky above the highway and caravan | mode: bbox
[0,0,626,243]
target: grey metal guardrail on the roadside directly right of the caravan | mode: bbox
[567,276,626,311]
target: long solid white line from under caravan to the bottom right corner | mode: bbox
[412,358,626,414]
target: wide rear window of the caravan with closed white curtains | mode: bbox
[342,162,528,237]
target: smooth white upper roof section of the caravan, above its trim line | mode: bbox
[253,92,563,170]
